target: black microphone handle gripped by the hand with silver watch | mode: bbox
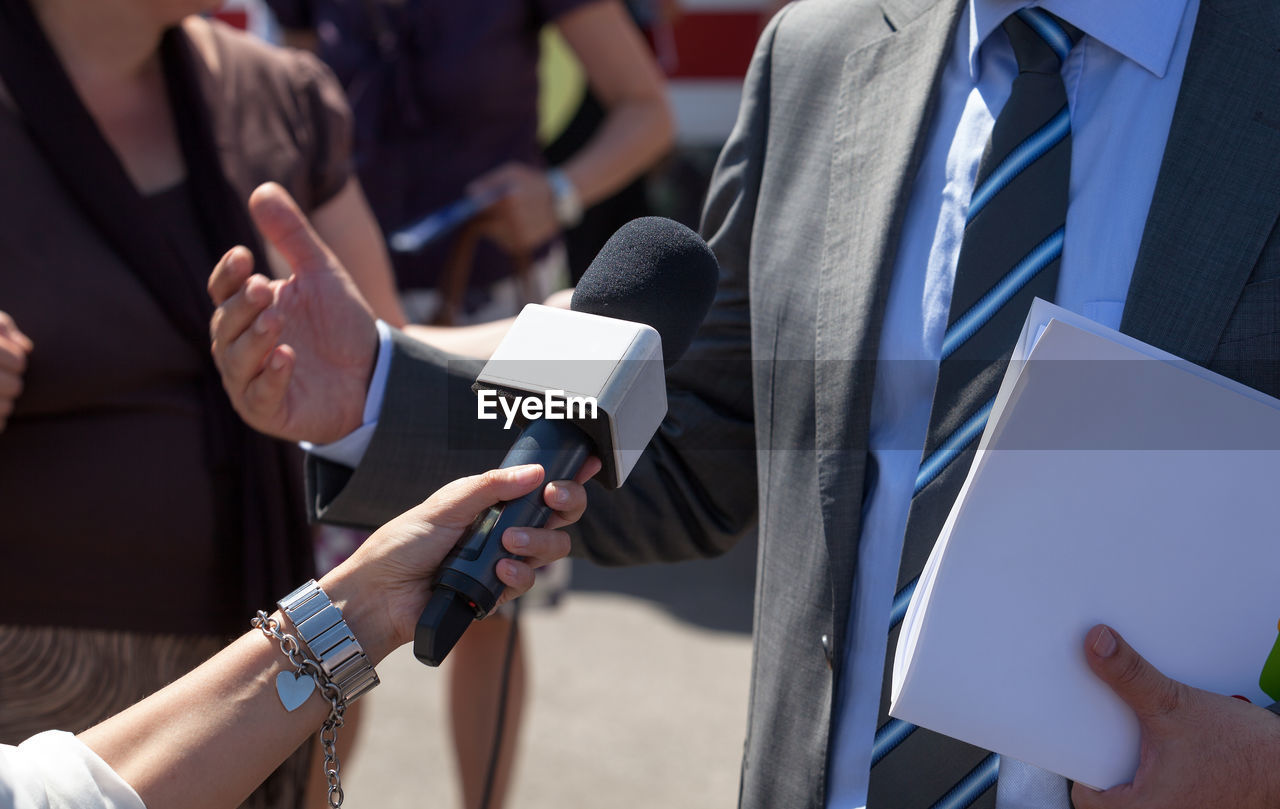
[413,419,591,666]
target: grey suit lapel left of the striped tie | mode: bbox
[814,0,959,661]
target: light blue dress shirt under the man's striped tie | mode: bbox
[815,0,1198,809]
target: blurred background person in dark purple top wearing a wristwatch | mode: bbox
[269,0,673,809]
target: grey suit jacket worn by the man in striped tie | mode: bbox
[310,0,1280,809]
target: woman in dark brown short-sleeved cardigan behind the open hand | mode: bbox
[0,0,402,806]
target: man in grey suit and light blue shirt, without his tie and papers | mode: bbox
[211,0,1280,809]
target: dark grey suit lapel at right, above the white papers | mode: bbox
[1120,0,1280,365]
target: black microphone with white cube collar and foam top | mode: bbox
[413,216,719,666]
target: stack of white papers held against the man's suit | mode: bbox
[891,301,1280,787]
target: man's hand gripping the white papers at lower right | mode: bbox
[1071,626,1280,809]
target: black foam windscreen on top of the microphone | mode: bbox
[570,216,719,366]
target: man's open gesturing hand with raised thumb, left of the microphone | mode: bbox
[209,183,378,444]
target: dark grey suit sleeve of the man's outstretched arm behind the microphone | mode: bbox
[307,12,776,565]
